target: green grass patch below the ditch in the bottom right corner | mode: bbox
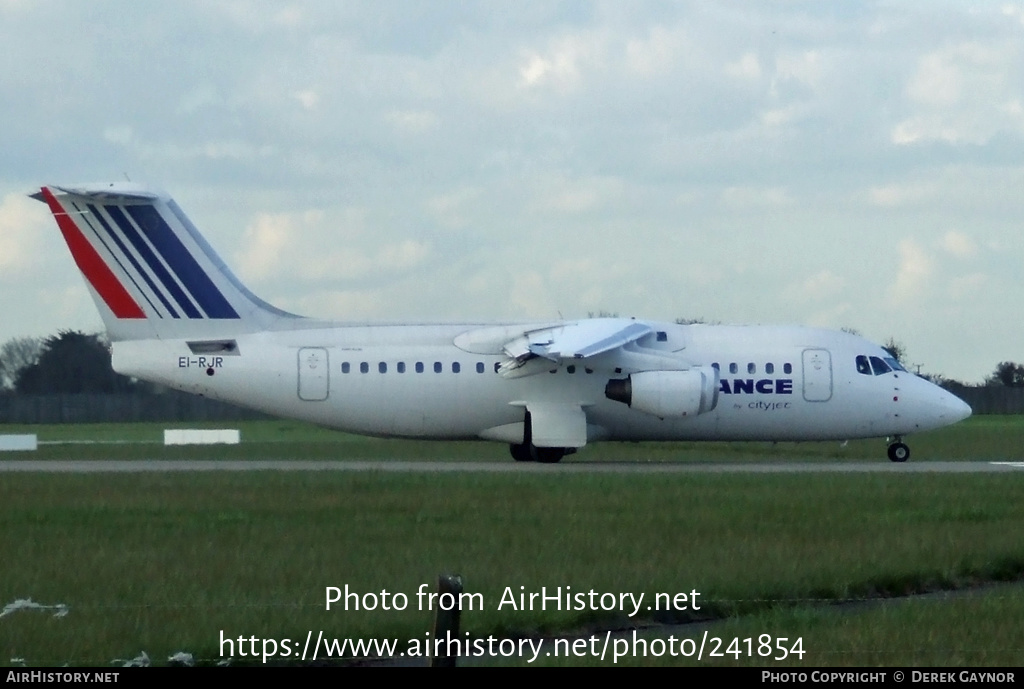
[512,584,1024,676]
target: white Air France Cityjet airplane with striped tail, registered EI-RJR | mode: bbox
[32,182,971,463]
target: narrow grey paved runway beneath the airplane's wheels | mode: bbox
[0,459,1024,474]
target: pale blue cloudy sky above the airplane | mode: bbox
[0,0,1024,383]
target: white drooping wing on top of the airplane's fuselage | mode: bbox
[499,318,654,378]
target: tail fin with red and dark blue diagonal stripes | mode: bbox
[33,183,297,341]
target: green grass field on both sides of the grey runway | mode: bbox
[0,417,1024,666]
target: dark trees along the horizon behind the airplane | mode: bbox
[0,325,1024,395]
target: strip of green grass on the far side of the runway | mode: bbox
[0,416,1024,462]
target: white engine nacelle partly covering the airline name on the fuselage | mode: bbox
[604,367,718,419]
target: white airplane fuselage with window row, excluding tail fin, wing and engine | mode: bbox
[114,320,970,443]
